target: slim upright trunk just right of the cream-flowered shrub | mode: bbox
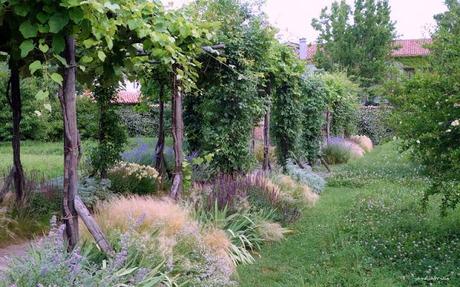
[170,69,184,199]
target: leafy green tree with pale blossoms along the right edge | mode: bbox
[390,0,460,214]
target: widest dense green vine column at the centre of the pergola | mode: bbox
[184,0,273,173]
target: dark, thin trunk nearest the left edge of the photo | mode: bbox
[9,59,25,205]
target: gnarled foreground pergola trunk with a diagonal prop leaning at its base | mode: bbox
[59,36,79,250]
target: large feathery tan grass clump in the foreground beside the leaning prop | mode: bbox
[82,195,239,286]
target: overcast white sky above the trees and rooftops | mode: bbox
[162,0,446,42]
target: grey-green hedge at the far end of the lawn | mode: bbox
[357,106,394,145]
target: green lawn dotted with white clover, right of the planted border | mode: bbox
[238,143,460,287]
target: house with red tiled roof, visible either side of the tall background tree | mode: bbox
[290,39,431,73]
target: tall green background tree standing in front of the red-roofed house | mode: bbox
[312,0,396,87]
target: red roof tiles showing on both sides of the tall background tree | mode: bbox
[307,39,431,60]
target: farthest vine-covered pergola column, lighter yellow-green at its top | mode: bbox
[321,72,359,136]
